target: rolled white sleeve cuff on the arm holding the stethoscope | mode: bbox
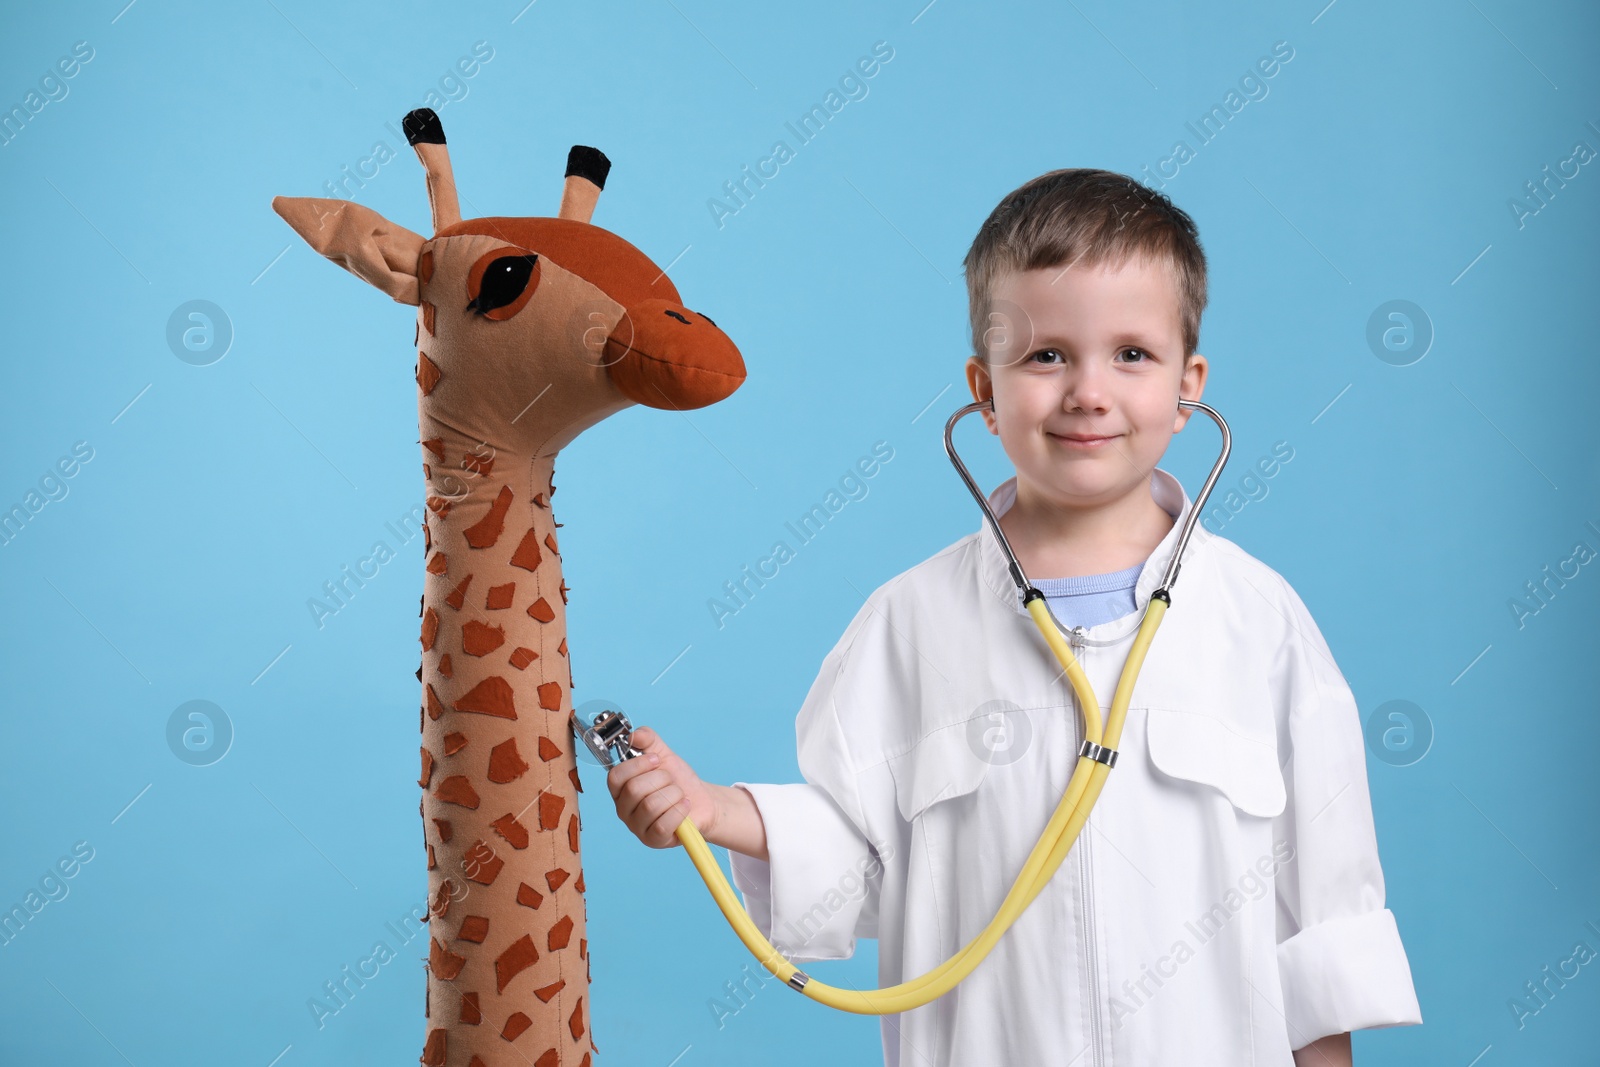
[728,782,877,961]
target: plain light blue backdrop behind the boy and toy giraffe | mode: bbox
[0,0,1600,1067]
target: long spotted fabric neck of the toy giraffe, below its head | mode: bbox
[419,435,594,1067]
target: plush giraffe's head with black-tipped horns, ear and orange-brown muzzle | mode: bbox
[272,107,744,458]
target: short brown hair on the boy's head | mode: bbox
[963,168,1206,363]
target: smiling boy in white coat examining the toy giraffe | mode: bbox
[608,170,1422,1067]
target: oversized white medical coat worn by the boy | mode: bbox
[730,469,1422,1067]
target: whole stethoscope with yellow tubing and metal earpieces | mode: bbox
[571,398,1232,1016]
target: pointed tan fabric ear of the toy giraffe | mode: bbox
[272,197,427,306]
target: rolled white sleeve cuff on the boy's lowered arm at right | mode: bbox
[1278,909,1422,1048]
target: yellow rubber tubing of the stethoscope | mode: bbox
[677,597,1166,1014]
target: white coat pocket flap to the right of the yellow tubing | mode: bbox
[1146,709,1288,817]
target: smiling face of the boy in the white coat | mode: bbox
[966,259,1206,509]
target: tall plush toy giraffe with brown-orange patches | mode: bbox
[272,107,744,1067]
